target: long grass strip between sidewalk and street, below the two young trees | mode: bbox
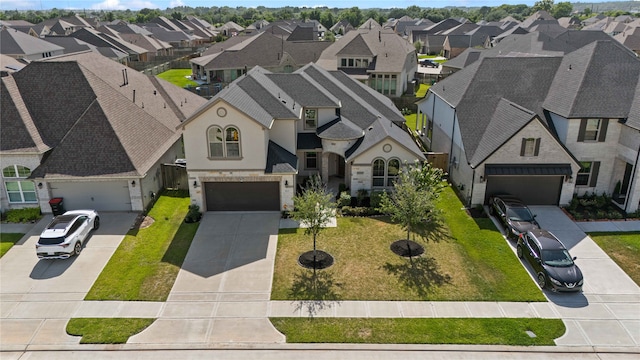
[270,318,566,346]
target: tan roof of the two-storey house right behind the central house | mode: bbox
[317,28,417,73]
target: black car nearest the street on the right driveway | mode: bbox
[516,229,584,291]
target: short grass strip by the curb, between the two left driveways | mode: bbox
[67,318,155,344]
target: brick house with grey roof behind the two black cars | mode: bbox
[418,40,640,212]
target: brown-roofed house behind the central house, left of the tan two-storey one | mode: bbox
[189,30,331,86]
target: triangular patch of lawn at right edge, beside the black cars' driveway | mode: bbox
[589,232,640,285]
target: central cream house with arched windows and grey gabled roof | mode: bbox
[179,64,425,211]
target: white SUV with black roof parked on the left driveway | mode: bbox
[36,210,100,259]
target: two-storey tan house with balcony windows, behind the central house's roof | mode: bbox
[317,27,418,98]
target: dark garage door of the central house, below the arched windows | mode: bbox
[204,182,280,211]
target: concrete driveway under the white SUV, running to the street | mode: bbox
[0,213,137,350]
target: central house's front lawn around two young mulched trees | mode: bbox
[271,184,545,301]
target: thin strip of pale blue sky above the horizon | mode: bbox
[0,0,624,10]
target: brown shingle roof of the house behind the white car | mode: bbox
[0,53,206,179]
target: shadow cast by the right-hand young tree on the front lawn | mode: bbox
[383,256,451,297]
